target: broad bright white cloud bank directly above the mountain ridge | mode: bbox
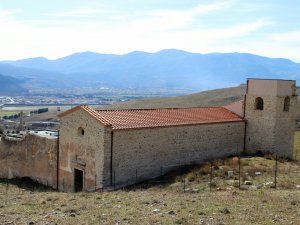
[0,1,300,60]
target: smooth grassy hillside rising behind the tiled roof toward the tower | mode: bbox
[102,85,246,109]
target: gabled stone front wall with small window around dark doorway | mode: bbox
[59,110,110,191]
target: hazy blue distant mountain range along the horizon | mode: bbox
[0,49,300,91]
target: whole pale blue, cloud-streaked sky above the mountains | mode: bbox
[0,0,300,62]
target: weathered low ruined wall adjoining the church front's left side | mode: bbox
[0,135,58,188]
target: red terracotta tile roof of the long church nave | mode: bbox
[60,105,244,130]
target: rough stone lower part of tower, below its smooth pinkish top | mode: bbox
[245,94,297,158]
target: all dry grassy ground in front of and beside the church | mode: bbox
[0,157,300,225]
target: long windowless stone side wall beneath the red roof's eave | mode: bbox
[112,122,245,187]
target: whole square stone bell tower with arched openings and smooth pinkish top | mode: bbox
[244,79,297,158]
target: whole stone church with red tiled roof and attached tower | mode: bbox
[57,79,297,191]
